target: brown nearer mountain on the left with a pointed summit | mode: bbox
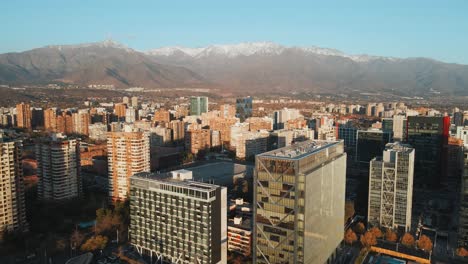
[0,41,206,87]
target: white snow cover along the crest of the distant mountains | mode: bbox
[145,42,397,62]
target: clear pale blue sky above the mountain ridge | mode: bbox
[0,0,468,64]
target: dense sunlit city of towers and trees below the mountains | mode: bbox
[0,92,468,264]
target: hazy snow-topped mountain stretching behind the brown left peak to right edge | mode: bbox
[147,43,468,95]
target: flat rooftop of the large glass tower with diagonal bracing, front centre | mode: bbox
[258,140,341,160]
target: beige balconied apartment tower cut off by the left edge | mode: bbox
[0,138,28,232]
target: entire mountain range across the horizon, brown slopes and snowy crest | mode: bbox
[0,41,468,95]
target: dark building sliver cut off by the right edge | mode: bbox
[458,147,468,247]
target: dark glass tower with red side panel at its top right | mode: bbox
[407,116,450,187]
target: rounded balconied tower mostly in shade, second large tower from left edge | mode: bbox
[36,135,82,201]
